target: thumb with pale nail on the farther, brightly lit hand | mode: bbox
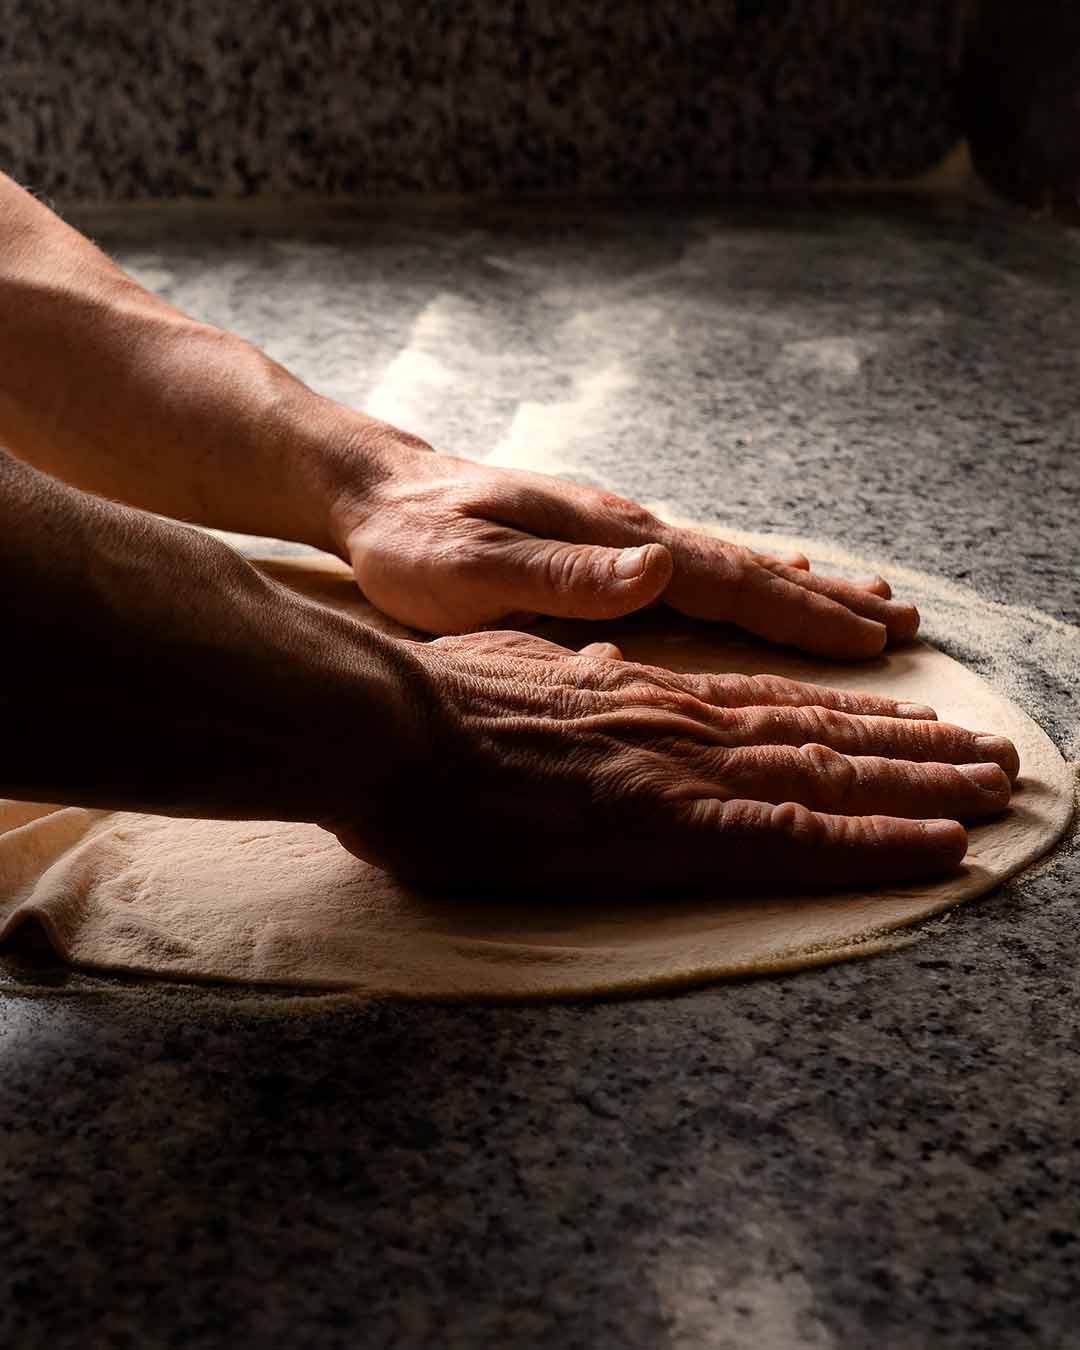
[500,539,674,618]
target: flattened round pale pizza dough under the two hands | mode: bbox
[0,558,1072,999]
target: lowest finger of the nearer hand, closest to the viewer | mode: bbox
[683,799,968,886]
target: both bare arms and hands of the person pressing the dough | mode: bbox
[0,168,1017,892]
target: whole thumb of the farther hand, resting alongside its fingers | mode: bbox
[460,527,672,629]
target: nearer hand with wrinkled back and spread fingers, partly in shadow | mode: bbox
[328,632,1019,895]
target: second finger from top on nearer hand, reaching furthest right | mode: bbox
[718,707,1021,782]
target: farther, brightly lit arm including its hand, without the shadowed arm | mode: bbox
[0,176,918,657]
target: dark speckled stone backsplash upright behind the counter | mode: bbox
[0,0,967,200]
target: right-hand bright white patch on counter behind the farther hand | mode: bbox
[485,363,635,474]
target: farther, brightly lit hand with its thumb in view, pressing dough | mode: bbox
[331,433,919,659]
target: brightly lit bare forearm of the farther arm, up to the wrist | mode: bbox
[0,174,410,548]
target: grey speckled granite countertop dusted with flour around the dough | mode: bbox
[0,198,1080,1350]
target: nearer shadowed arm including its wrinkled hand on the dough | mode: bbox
[0,452,1017,892]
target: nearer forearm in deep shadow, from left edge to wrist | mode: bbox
[0,452,410,821]
